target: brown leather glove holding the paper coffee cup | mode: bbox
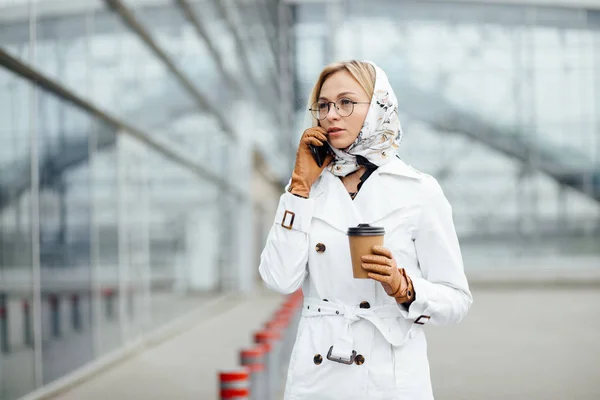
[362,246,415,305]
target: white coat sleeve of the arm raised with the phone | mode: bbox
[258,191,314,294]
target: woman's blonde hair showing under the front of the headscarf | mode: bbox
[308,60,375,126]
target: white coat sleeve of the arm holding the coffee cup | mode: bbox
[402,176,473,325]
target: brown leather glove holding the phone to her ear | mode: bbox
[288,126,333,198]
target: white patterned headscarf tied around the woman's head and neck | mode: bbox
[327,61,402,176]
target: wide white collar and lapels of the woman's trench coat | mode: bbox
[311,158,421,233]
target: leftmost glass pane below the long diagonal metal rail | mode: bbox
[0,68,35,400]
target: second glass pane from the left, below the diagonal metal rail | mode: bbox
[38,92,98,383]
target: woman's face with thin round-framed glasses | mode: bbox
[317,70,371,149]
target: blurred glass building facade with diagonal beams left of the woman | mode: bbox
[0,0,289,400]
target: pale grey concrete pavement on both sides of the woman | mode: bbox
[39,287,600,400]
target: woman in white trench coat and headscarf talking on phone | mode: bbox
[259,61,472,400]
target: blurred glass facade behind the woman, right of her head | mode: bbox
[294,0,600,265]
